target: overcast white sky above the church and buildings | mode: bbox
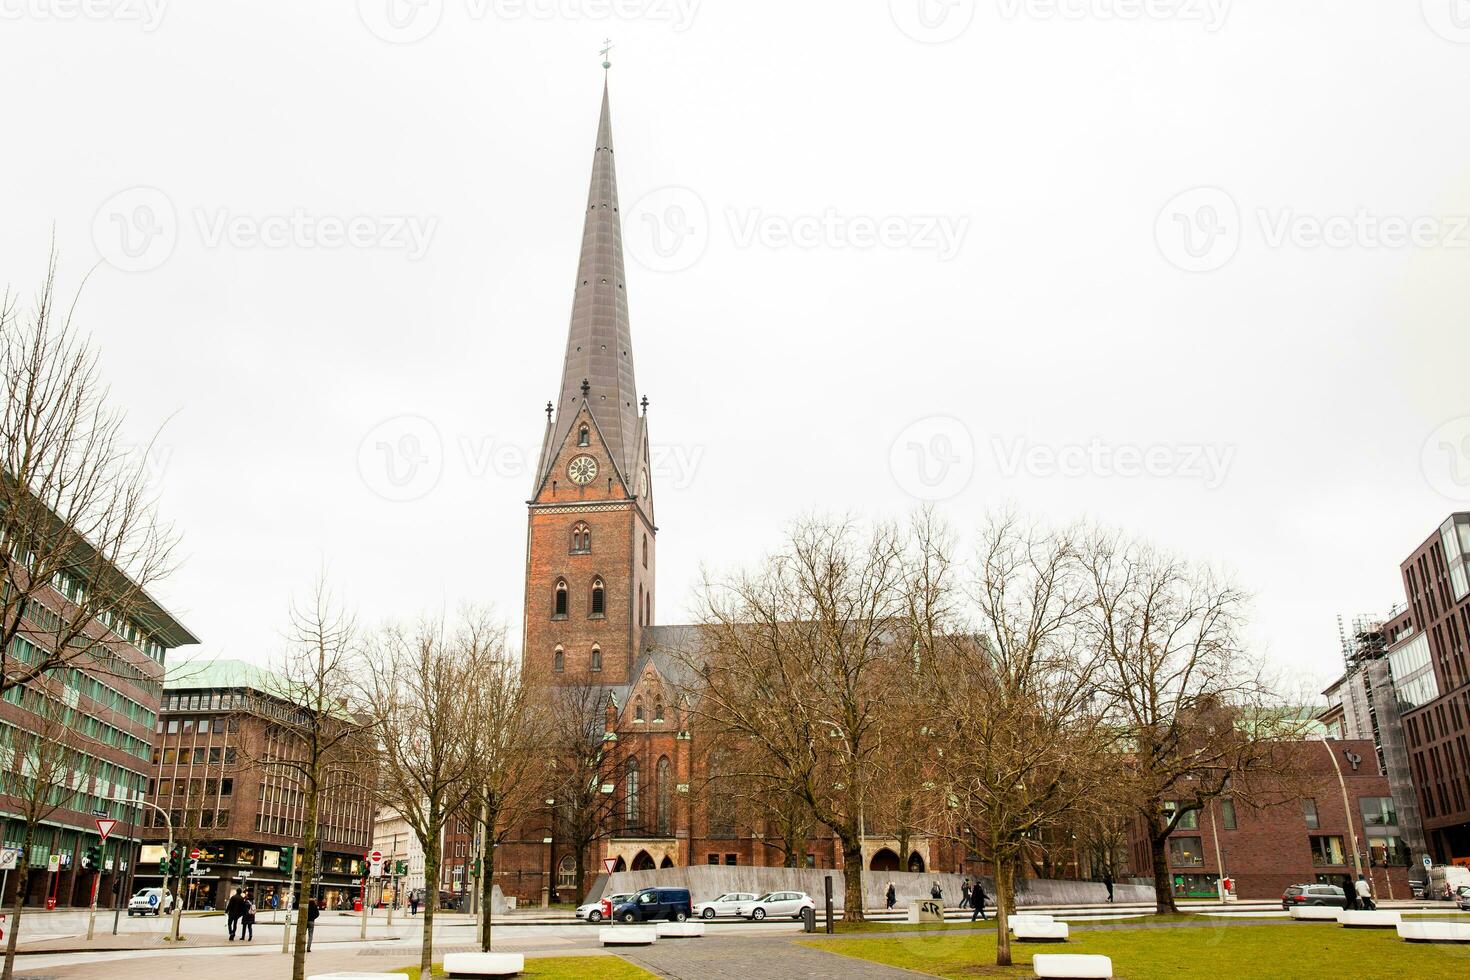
[0,0,1470,690]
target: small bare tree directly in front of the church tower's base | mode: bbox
[545,677,639,902]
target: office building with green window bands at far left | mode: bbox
[0,550,198,907]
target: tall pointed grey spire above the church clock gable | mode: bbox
[539,79,638,482]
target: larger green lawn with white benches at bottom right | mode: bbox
[806,920,1470,980]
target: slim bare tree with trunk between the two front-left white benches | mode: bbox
[362,620,487,976]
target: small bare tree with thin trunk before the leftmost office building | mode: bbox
[0,676,100,980]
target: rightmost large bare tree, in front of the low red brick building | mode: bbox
[1083,532,1301,912]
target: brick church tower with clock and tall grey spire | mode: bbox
[523,82,656,686]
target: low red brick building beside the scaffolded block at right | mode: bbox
[1129,739,1413,899]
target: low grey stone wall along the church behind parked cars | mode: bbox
[587,864,1154,911]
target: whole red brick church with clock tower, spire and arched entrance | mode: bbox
[495,85,952,902]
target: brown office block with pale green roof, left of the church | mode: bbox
[137,660,375,908]
